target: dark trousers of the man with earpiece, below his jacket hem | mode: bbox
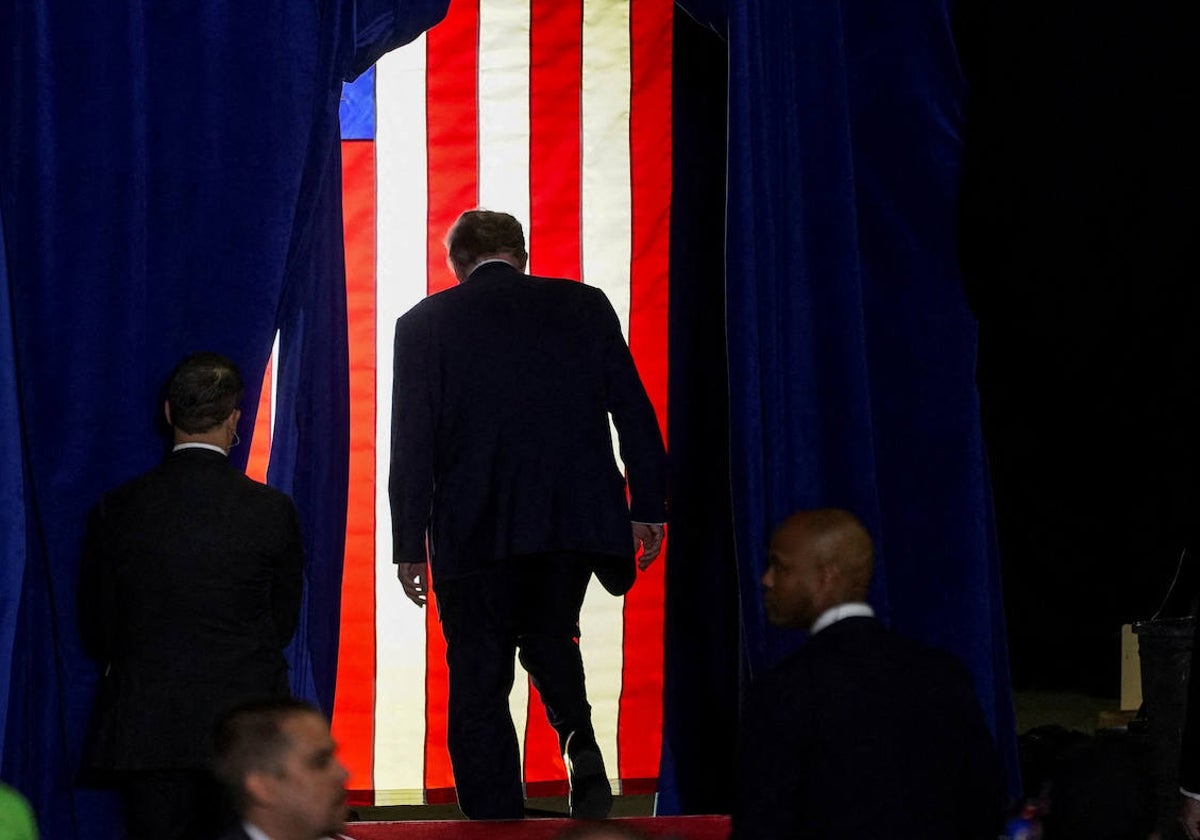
[120,770,238,840]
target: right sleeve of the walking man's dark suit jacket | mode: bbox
[595,289,667,522]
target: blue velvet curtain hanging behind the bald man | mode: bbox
[667,0,1016,806]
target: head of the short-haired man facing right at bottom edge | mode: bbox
[215,698,349,840]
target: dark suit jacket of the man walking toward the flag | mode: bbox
[390,263,666,583]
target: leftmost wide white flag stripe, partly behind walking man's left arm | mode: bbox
[374,36,436,805]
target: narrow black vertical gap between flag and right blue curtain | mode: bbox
[660,10,740,814]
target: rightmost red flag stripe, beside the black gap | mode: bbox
[617,0,672,780]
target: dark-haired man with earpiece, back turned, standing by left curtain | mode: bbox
[79,353,304,840]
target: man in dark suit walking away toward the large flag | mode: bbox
[390,210,666,818]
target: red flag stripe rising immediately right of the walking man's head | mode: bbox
[524,0,583,782]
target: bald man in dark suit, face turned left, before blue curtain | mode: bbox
[732,510,1002,840]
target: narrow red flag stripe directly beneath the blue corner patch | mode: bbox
[332,140,376,791]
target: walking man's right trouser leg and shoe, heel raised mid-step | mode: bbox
[517,553,612,820]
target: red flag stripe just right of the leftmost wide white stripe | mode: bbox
[425,0,479,790]
